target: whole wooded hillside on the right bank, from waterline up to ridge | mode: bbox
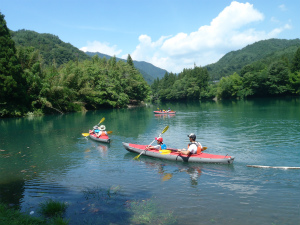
[151,39,300,101]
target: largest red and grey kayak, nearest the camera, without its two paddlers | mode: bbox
[123,142,234,164]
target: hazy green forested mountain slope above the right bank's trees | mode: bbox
[204,39,300,80]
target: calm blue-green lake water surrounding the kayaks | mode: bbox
[0,99,300,225]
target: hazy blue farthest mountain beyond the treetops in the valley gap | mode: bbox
[86,52,167,84]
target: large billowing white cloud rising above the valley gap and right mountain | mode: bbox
[131,1,290,73]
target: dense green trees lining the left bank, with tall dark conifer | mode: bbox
[0,13,150,117]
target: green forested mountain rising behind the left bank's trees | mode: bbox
[10,30,90,67]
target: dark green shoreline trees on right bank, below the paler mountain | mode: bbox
[151,48,300,101]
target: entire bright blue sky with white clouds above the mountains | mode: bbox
[0,0,300,73]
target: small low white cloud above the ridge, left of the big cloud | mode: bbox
[80,41,122,56]
